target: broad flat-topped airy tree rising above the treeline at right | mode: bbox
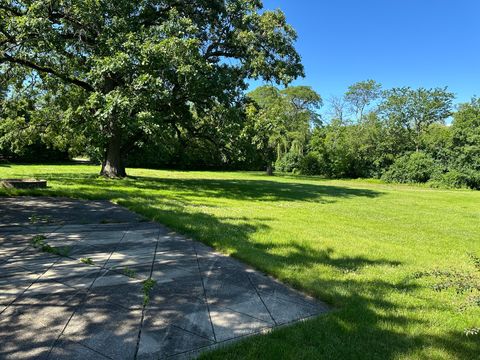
[380,87,454,151]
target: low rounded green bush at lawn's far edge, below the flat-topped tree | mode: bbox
[382,152,439,183]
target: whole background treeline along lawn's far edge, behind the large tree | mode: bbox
[0,80,480,189]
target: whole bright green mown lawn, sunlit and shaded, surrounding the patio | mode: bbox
[0,165,480,360]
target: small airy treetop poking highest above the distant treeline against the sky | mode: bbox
[345,80,382,122]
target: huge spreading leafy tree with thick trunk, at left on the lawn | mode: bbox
[0,0,303,177]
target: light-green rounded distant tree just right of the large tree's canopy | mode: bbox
[247,86,323,174]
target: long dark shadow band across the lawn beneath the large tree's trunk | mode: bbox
[12,173,383,203]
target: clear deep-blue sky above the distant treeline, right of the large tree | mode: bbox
[251,0,480,106]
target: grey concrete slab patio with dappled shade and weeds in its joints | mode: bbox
[0,197,328,359]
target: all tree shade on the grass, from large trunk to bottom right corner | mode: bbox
[0,174,479,359]
